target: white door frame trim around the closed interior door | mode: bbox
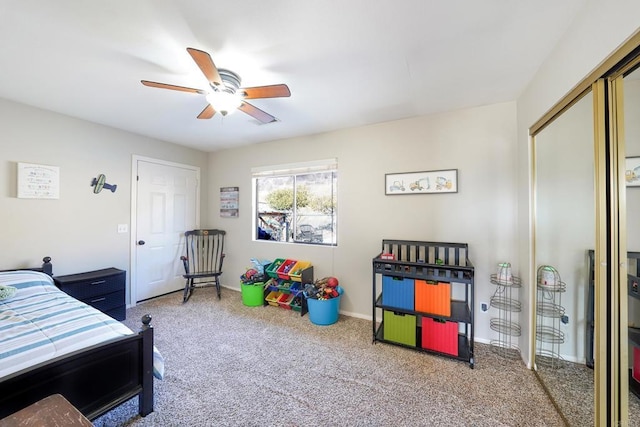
[127,154,202,307]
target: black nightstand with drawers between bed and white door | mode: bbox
[53,268,126,320]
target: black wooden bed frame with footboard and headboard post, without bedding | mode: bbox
[0,257,153,420]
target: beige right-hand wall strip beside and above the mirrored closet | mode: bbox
[517,0,640,363]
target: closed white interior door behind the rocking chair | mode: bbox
[134,160,200,302]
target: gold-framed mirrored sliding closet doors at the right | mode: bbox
[531,32,640,426]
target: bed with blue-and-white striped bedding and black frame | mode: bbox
[0,263,163,420]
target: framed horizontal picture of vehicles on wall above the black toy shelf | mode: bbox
[384,169,458,196]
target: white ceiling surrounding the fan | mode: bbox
[0,0,586,151]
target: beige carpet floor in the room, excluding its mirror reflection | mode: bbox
[94,288,563,427]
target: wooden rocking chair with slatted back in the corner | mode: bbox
[180,230,226,303]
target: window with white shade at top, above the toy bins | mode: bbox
[252,159,338,246]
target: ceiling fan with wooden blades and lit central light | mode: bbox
[141,47,291,123]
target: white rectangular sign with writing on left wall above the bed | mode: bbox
[18,163,60,199]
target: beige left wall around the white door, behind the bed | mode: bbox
[0,100,208,300]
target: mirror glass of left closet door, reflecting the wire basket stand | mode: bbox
[535,89,595,426]
